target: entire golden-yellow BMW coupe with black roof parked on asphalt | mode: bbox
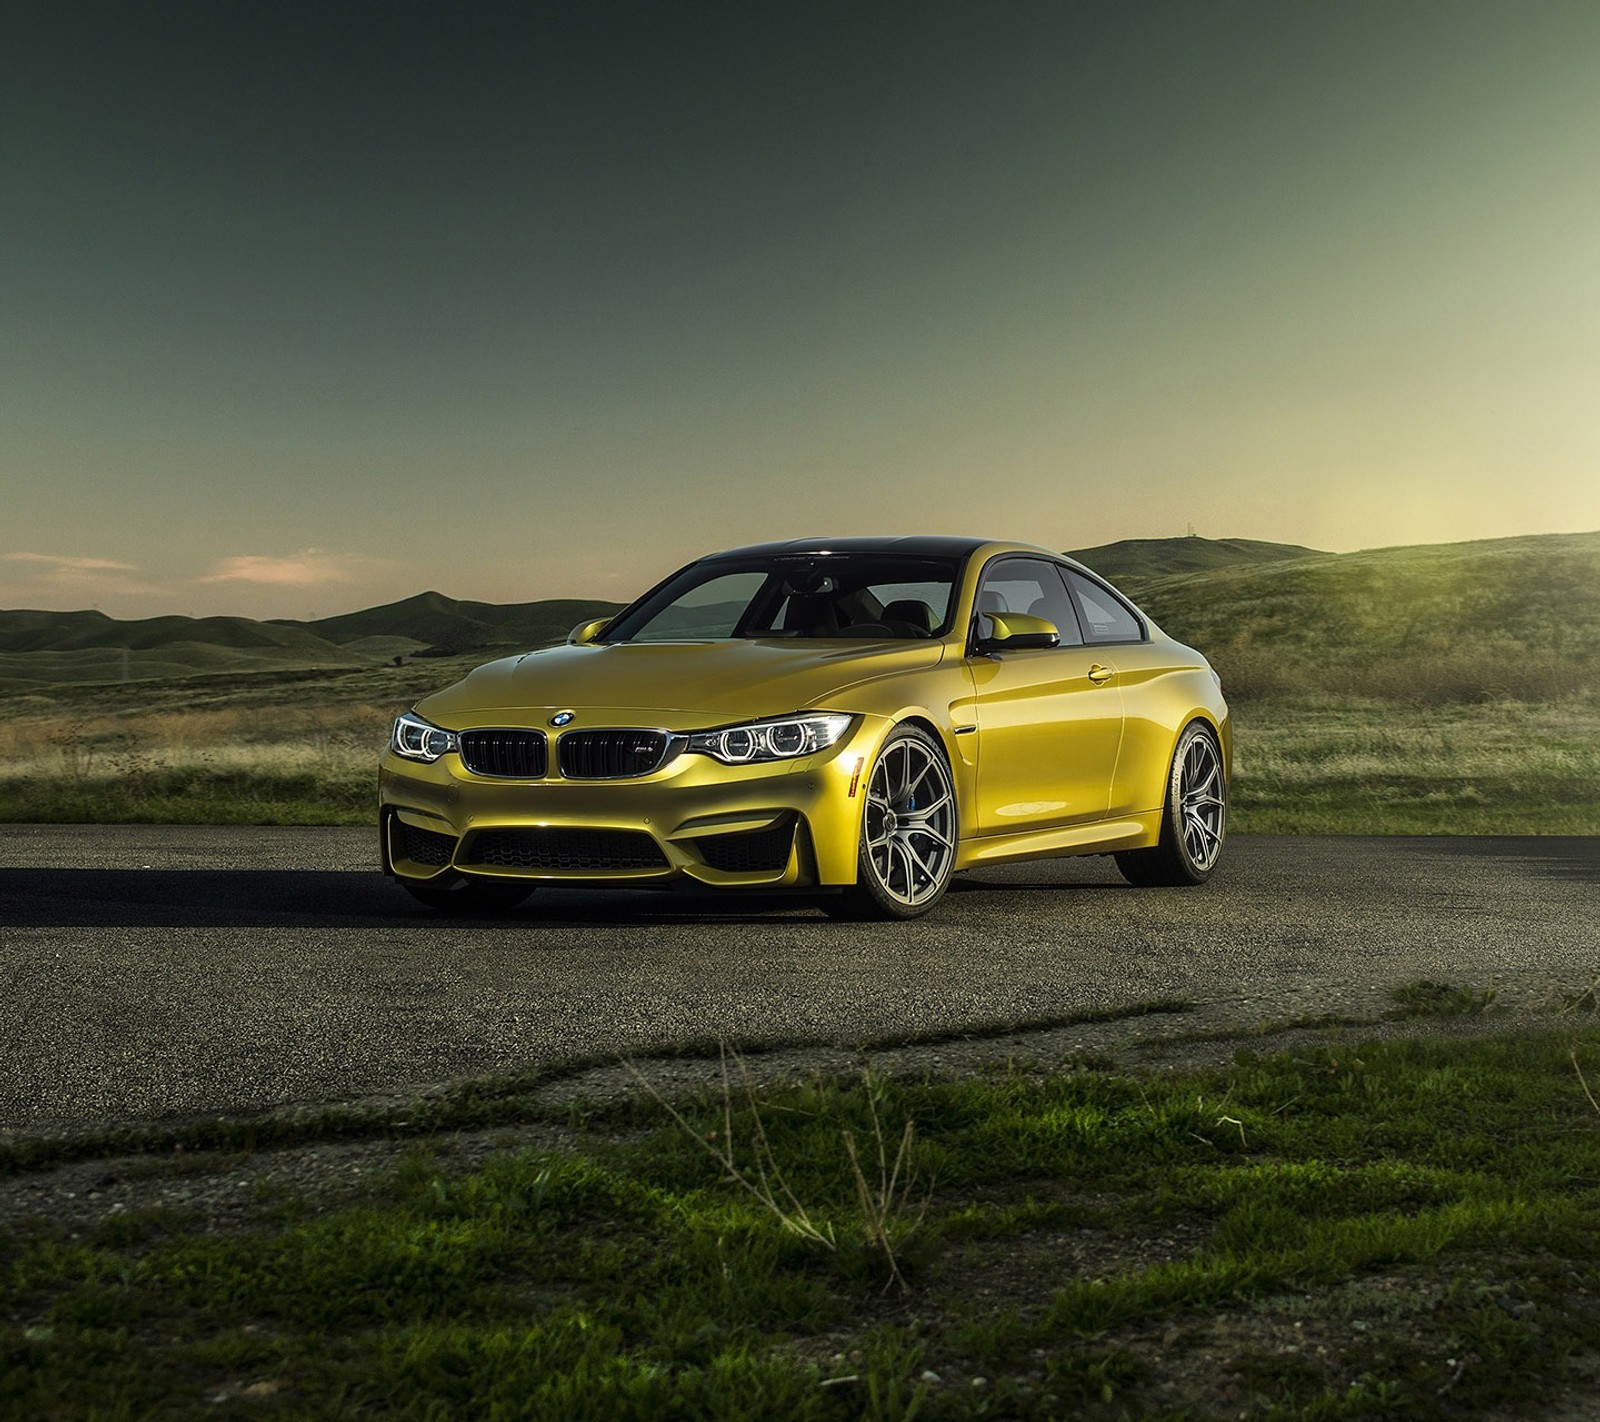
[379,537,1232,918]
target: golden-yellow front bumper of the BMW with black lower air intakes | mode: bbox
[378,717,888,888]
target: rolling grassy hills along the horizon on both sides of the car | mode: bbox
[0,533,1600,701]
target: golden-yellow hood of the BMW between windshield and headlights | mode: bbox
[418,638,944,729]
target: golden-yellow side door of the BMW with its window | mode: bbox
[968,557,1123,835]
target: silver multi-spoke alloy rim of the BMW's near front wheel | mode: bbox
[866,736,955,909]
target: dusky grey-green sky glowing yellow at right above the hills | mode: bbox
[0,0,1600,617]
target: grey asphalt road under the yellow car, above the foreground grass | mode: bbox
[0,825,1600,1128]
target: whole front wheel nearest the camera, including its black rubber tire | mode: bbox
[822,726,958,920]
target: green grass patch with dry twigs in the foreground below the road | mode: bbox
[9,1023,1600,1419]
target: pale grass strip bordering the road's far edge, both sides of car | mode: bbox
[0,678,1600,835]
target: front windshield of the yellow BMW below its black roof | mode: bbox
[602,553,960,641]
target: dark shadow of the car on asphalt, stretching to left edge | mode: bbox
[0,869,1118,931]
